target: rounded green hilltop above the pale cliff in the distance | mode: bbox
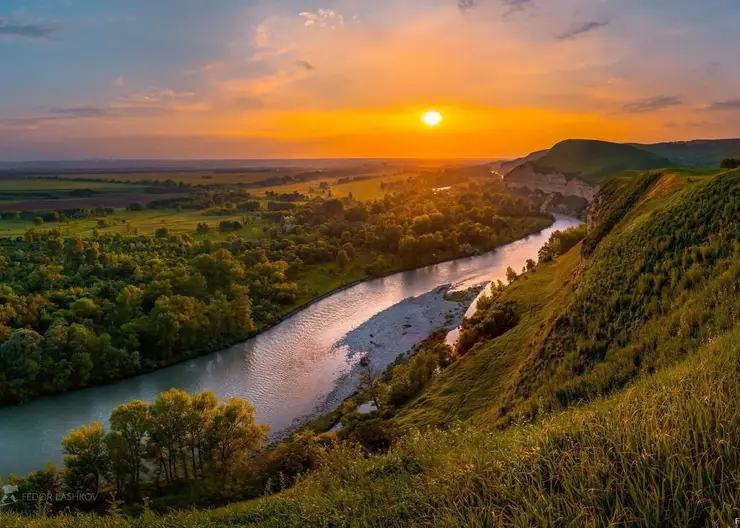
[514,139,675,183]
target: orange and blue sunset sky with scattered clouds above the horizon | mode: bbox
[0,0,740,161]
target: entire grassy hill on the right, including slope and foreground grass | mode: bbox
[0,171,740,528]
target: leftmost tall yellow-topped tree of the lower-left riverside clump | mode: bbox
[62,421,110,493]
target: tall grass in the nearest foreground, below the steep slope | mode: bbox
[0,324,740,528]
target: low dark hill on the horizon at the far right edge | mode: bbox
[633,139,740,168]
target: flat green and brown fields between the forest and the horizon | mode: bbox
[0,166,468,240]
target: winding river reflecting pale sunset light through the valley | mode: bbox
[0,215,580,477]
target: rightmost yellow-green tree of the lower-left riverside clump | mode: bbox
[208,398,269,478]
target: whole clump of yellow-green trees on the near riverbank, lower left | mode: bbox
[4,389,269,510]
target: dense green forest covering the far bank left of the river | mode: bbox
[0,182,552,405]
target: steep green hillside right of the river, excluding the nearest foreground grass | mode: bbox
[399,171,740,426]
